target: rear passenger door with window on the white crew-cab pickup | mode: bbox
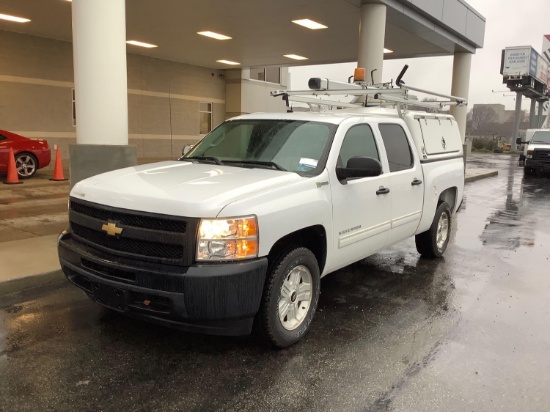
[378,123,425,243]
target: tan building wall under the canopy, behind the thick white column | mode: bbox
[0,31,226,165]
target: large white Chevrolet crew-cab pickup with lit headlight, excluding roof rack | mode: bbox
[58,75,464,347]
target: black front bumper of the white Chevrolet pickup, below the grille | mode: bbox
[58,232,267,335]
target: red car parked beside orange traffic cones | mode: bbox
[0,130,52,179]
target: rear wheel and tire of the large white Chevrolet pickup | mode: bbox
[415,202,451,258]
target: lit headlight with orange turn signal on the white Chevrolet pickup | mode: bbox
[197,216,258,261]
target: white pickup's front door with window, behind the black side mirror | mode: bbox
[331,123,392,267]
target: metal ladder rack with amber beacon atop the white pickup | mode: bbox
[271,65,468,117]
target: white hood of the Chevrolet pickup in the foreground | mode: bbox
[71,161,305,217]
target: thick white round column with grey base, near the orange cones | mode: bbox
[70,0,137,185]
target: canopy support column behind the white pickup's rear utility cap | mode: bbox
[451,52,472,143]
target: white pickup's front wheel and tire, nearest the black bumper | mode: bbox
[258,247,321,348]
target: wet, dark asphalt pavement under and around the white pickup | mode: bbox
[0,155,550,411]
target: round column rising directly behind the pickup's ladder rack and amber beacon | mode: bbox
[357,3,386,83]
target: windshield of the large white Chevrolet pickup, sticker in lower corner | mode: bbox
[180,119,336,175]
